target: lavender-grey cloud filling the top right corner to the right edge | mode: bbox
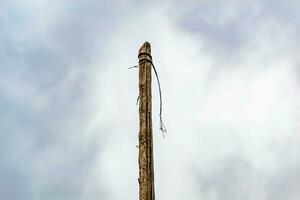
[171,0,300,58]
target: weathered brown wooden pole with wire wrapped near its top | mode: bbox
[138,42,155,200]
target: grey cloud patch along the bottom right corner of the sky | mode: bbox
[195,146,300,200]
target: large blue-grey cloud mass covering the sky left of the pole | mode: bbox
[0,1,122,200]
